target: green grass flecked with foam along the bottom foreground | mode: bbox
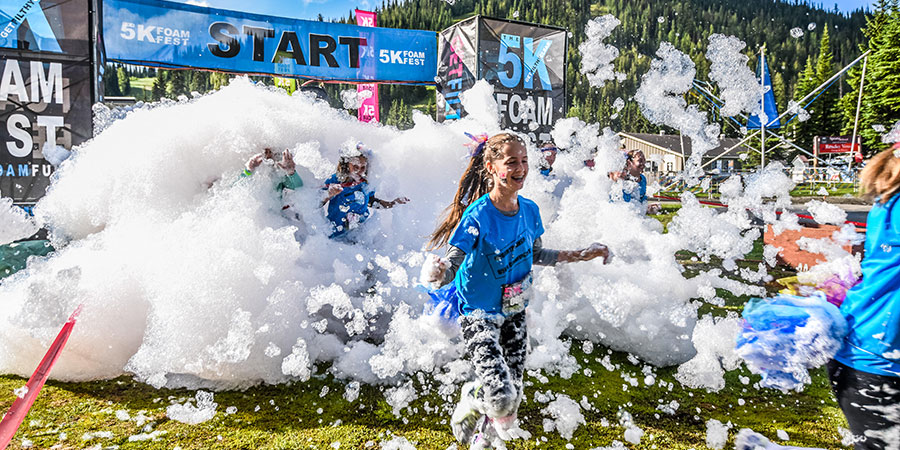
[0,229,846,450]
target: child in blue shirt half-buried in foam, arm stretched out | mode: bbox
[322,143,409,238]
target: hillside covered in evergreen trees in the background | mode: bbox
[108,0,900,156]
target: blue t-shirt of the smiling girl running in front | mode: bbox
[449,194,544,314]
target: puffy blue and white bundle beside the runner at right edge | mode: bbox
[736,292,847,391]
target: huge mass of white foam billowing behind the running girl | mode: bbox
[0,14,828,436]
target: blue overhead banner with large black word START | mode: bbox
[103,0,437,84]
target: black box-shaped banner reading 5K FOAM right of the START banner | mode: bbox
[437,16,568,140]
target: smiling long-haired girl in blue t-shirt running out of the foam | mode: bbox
[425,133,609,446]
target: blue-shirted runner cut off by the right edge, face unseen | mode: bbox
[828,143,900,450]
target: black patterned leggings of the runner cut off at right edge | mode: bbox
[828,360,900,450]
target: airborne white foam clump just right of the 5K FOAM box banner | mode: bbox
[578,14,625,88]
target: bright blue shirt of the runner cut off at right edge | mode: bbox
[835,195,900,377]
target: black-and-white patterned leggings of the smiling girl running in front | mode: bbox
[460,311,528,418]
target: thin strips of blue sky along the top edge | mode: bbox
[173,0,871,19]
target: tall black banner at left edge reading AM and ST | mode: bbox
[0,0,94,206]
